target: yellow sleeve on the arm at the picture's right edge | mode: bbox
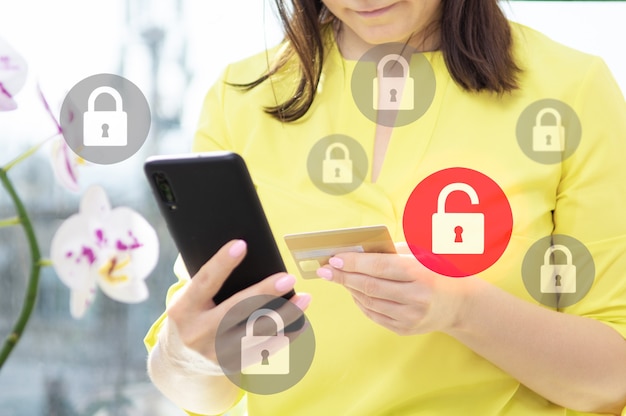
[554,58,626,338]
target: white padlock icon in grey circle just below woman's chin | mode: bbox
[372,54,415,110]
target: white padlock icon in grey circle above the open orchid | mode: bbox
[83,86,128,146]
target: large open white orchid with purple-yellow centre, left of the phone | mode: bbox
[50,186,159,318]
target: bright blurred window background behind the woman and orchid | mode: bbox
[0,0,626,416]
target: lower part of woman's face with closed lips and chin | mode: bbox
[322,0,438,49]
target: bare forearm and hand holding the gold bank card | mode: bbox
[318,247,626,414]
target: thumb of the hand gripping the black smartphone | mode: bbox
[186,240,247,307]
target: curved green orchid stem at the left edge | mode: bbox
[0,167,41,369]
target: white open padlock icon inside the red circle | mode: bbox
[432,182,485,254]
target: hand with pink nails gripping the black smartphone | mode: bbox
[166,240,311,363]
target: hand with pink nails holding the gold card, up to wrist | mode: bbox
[317,245,474,335]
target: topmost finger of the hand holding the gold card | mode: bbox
[321,253,417,281]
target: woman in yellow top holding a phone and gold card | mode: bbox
[146,0,626,416]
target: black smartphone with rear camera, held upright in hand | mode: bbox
[144,152,295,304]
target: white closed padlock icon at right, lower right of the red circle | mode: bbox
[540,244,576,293]
